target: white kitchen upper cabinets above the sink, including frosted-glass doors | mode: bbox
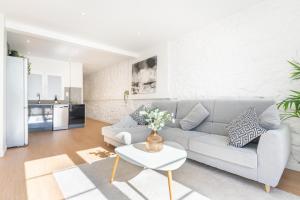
[28,57,83,100]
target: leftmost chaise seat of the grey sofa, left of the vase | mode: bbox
[102,126,151,144]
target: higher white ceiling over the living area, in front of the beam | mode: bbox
[0,0,262,52]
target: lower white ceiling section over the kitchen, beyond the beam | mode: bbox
[7,32,130,74]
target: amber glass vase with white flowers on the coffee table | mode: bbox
[140,108,174,152]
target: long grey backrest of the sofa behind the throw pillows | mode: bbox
[152,98,275,135]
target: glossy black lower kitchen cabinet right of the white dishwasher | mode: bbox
[69,104,85,128]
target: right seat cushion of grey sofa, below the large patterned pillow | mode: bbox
[189,134,257,168]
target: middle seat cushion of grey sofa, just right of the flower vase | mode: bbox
[158,127,207,149]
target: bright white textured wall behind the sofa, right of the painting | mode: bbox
[169,0,300,170]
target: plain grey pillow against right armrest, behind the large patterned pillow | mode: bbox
[259,105,281,130]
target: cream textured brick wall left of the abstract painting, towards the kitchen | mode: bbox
[83,61,156,123]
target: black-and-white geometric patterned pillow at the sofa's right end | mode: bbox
[226,107,267,147]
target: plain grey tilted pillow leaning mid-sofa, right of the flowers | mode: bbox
[179,103,209,131]
